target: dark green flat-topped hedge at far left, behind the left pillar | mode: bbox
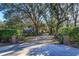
[0,29,20,42]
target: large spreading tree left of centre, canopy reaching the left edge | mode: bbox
[2,3,46,34]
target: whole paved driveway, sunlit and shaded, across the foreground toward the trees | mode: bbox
[0,37,79,56]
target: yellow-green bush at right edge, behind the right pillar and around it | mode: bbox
[58,27,79,43]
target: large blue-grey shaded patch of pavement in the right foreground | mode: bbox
[29,44,79,56]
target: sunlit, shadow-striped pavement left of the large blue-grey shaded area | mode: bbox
[0,43,46,56]
